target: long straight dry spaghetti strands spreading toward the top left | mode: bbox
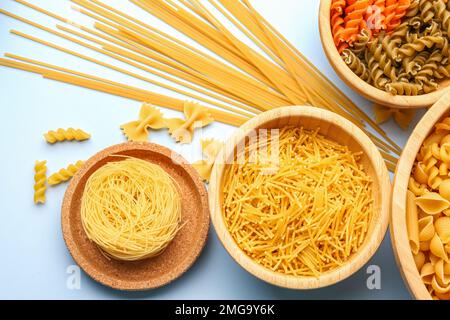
[2,0,399,168]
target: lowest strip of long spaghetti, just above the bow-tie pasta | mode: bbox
[0,58,249,126]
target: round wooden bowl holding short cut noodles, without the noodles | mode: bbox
[209,106,391,289]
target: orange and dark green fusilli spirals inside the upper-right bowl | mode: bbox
[332,0,450,95]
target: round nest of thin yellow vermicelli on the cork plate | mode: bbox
[81,157,181,261]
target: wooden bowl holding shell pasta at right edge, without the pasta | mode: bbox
[391,92,450,299]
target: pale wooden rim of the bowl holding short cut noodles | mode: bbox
[209,106,391,289]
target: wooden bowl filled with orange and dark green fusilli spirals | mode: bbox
[319,0,450,108]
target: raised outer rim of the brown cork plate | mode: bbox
[61,142,210,291]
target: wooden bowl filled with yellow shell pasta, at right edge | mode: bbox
[390,92,450,299]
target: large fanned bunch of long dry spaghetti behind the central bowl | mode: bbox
[0,0,400,169]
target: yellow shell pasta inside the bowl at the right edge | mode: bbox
[406,117,450,300]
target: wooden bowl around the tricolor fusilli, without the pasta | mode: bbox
[319,0,450,109]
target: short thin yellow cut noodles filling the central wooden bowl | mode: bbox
[222,127,373,276]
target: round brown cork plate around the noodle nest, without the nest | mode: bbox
[61,142,209,290]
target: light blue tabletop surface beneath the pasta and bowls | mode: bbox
[0,0,418,299]
